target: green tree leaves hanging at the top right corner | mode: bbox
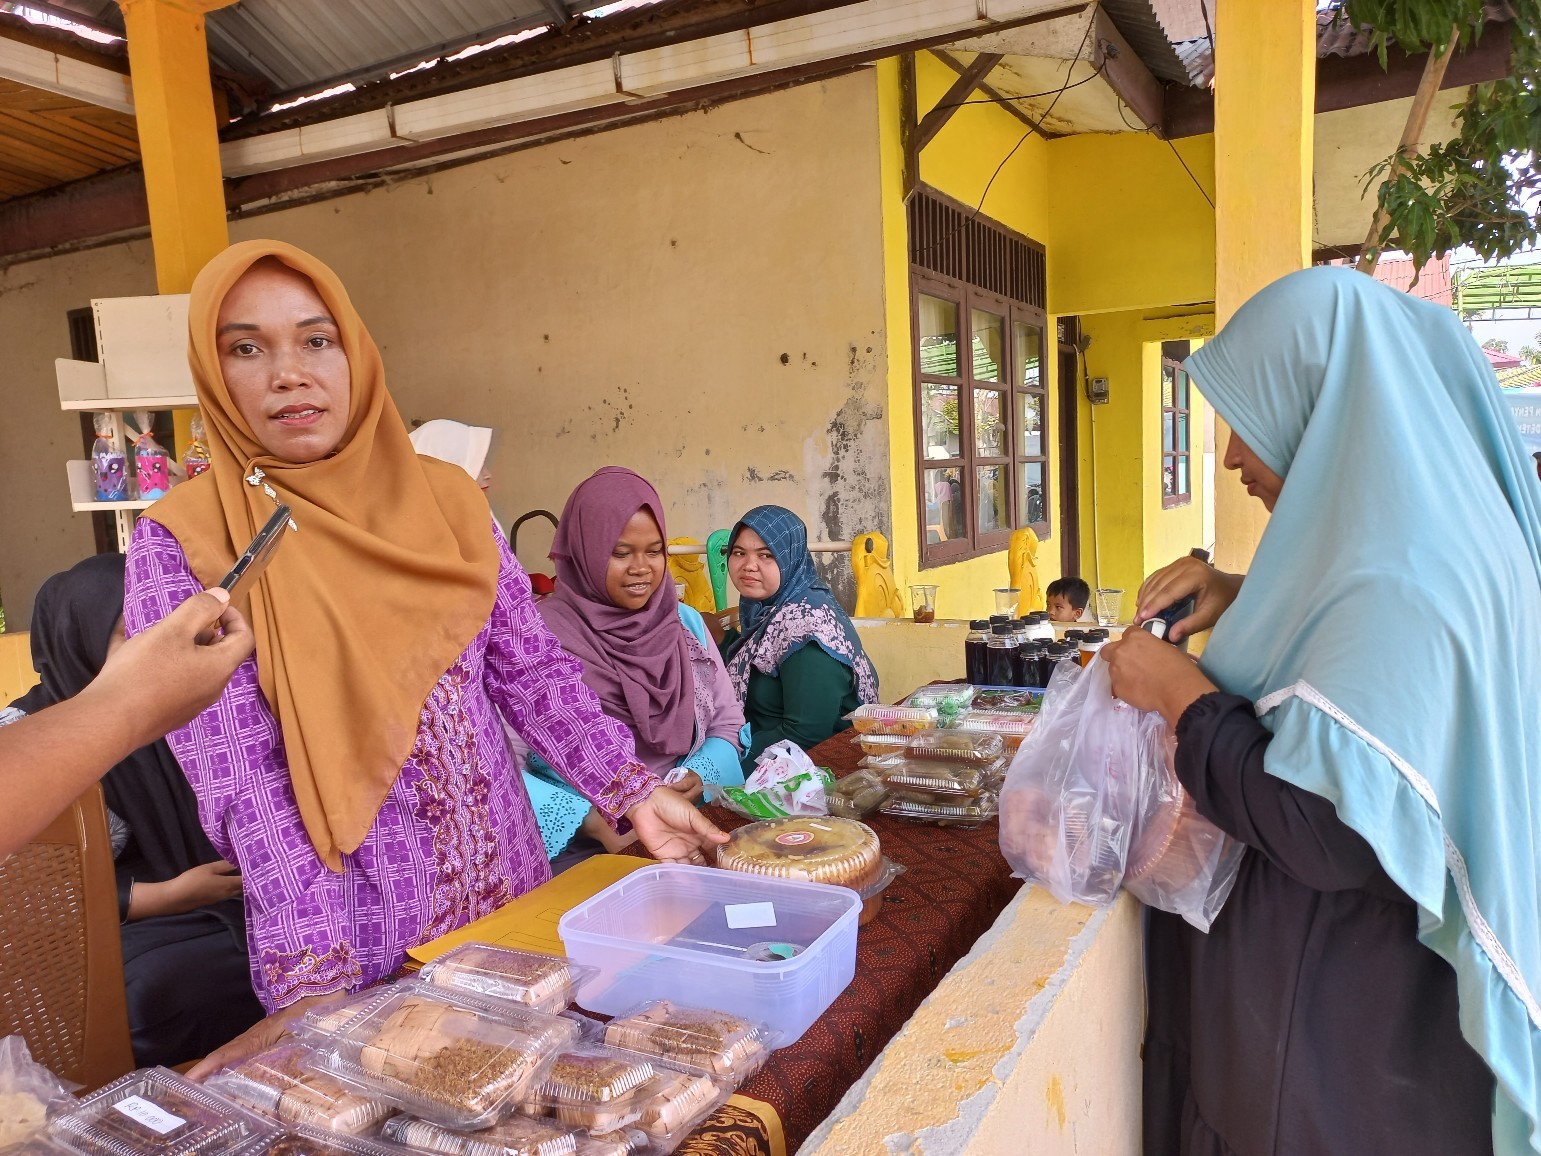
[1344,0,1541,268]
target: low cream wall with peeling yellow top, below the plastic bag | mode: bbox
[798,888,1143,1156]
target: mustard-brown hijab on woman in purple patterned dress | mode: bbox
[145,240,498,871]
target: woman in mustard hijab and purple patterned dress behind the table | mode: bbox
[123,240,726,1071]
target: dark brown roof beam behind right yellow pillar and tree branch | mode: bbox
[1163,22,1512,139]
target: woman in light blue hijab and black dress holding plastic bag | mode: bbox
[1105,268,1541,1156]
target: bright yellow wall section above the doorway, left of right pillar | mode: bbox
[1043,133,1214,314]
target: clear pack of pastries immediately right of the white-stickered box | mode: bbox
[205,1040,393,1134]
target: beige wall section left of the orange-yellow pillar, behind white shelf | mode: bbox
[0,242,156,630]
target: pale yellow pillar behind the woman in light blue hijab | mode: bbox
[1214,0,1316,572]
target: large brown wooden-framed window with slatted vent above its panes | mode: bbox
[909,190,1049,567]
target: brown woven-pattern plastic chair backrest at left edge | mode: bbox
[0,786,133,1088]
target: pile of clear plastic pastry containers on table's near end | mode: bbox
[39,943,778,1156]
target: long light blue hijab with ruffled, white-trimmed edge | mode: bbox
[1188,268,1541,1156]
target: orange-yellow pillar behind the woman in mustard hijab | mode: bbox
[119,0,234,455]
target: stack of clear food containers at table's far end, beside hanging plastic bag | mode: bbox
[829,683,1043,826]
